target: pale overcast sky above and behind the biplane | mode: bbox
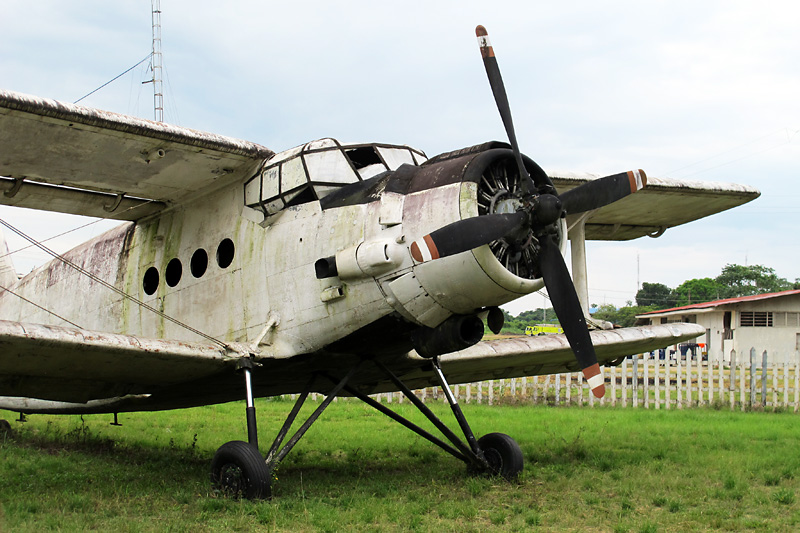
[0,0,800,314]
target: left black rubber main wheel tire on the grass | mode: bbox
[211,440,272,500]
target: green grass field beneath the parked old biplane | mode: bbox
[0,400,800,532]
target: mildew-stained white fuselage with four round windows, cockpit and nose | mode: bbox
[0,140,564,358]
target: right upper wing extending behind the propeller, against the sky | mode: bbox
[552,172,761,241]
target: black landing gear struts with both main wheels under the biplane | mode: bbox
[211,357,524,499]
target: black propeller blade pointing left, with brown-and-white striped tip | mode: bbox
[411,211,528,263]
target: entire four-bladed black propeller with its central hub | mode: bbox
[411,26,647,398]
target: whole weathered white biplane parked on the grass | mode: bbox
[0,27,759,499]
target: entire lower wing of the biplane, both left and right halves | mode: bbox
[0,321,705,414]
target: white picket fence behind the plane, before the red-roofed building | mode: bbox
[376,348,800,412]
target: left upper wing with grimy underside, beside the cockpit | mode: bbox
[0,90,273,220]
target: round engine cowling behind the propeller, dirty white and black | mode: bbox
[382,143,566,328]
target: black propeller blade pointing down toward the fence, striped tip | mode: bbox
[539,235,606,398]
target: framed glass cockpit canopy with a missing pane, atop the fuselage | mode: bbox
[244,138,427,217]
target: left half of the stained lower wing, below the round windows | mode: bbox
[0,321,241,402]
